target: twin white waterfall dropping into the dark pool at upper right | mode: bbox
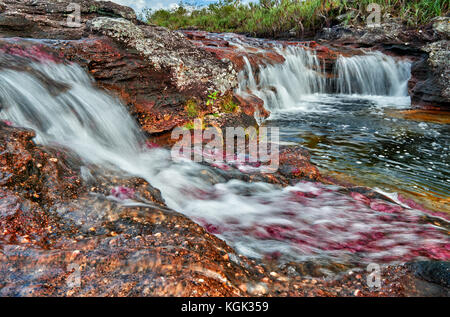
[237,46,411,112]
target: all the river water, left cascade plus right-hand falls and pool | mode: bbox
[0,44,450,266]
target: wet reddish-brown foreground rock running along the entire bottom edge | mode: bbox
[0,113,447,296]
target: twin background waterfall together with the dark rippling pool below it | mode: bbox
[239,47,450,212]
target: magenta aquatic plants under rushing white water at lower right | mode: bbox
[191,182,450,263]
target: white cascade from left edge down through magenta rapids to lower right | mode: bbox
[0,56,450,264]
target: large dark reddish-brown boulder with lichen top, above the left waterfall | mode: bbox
[0,0,243,133]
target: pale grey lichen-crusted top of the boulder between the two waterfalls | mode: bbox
[87,17,237,94]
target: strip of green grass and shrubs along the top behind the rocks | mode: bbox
[144,0,449,36]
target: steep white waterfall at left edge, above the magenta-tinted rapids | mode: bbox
[0,63,144,164]
